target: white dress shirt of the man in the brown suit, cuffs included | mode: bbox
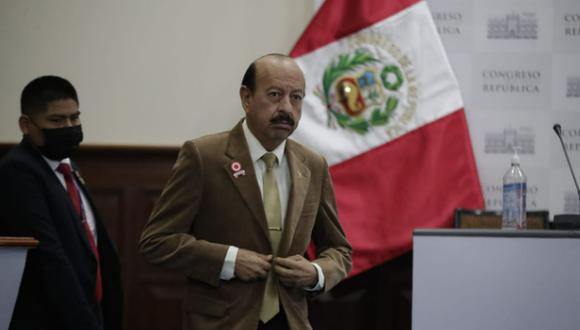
[220,120,324,291]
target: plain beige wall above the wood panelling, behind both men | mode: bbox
[0,0,314,145]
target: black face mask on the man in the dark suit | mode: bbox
[38,125,83,160]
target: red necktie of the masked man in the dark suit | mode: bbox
[57,163,103,304]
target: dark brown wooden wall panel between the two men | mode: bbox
[75,147,185,330]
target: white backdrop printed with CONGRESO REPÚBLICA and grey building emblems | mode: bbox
[427,0,580,216]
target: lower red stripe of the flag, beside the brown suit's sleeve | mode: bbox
[330,109,484,276]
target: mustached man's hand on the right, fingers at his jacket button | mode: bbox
[274,255,318,288]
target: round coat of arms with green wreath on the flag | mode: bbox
[314,32,418,135]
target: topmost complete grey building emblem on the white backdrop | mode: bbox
[487,13,538,39]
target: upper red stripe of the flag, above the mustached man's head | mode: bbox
[290,0,420,57]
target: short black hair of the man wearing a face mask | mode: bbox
[20,76,79,115]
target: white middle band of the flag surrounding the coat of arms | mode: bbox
[292,2,463,165]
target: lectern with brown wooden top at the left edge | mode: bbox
[0,236,38,329]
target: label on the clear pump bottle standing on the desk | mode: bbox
[502,183,527,229]
